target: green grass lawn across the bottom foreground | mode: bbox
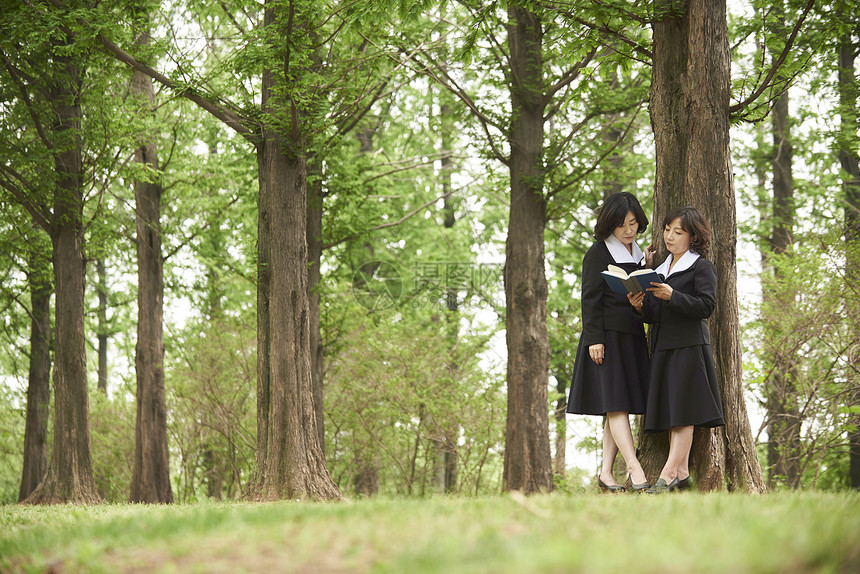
[0,492,860,574]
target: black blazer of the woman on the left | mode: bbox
[582,240,644,346]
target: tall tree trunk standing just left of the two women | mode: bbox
[504,6,553,493]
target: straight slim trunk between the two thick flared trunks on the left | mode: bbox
[129,31,173,503]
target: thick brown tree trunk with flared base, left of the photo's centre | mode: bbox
[251,0,343,500]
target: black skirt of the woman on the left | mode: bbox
[567,331,648,415]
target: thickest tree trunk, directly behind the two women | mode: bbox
[640,0,765,492]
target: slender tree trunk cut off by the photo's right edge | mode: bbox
[838,31,860,489]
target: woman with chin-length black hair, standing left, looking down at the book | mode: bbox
[567,192,654,492]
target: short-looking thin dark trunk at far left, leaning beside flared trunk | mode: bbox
[18,234,54,502]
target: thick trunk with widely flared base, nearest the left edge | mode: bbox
[24,48,100,504]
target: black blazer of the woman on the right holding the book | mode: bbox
[642,257,717,352]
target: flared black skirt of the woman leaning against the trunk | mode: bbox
[645,345,726,432]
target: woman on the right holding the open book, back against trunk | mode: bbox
[628,207,725,493]
